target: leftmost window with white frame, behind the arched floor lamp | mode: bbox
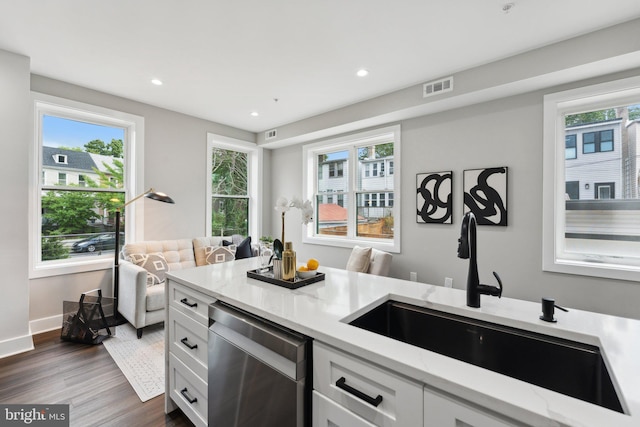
[29,94,144,277]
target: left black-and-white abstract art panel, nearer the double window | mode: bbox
[416,171,453,224]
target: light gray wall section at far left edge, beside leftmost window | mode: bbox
[0,50,33,356]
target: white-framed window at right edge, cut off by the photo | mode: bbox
[543,77,640,281]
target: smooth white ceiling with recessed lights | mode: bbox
[0,0,640,132]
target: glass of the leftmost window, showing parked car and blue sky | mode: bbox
[40,115,125,261]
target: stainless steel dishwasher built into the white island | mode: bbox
[208,301,311,427]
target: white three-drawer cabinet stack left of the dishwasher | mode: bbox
[165,280,215,426]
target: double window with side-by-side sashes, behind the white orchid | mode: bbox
[303,126,400,252]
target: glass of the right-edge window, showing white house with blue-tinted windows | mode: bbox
[564,104,640,262]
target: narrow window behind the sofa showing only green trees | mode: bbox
[206,134,262,241]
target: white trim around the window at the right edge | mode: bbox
[542,77,640,281]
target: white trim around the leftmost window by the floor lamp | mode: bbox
[29,92,146,279]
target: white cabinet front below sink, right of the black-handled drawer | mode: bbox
[424,389,519,427]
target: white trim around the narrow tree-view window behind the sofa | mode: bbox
[205,132,264,242]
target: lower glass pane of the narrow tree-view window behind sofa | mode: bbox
[211,197,249,236]
